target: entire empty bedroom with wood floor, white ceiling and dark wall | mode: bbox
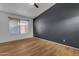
[0,3,79,56]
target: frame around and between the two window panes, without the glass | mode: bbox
[8,17,29,35]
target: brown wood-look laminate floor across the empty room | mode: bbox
[0,38,79,56]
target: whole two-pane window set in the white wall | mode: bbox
[9,18,28,34]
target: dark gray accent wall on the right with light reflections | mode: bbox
[34,3,79,48]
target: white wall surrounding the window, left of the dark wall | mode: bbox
[0,12,33,43]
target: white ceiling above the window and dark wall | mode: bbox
[0,3,55,18]
